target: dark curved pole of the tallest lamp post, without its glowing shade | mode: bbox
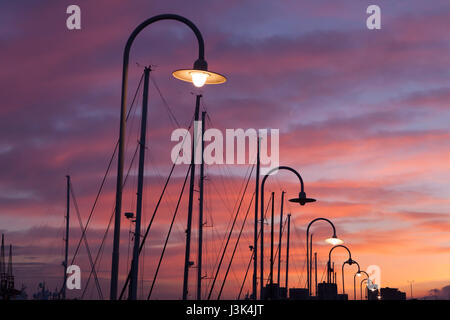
[110,14,207,300]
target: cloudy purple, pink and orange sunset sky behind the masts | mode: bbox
[0,0,450,299]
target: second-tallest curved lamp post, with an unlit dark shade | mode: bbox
[260,166,316,299]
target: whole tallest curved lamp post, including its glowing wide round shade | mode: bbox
[110,14,226,300]
